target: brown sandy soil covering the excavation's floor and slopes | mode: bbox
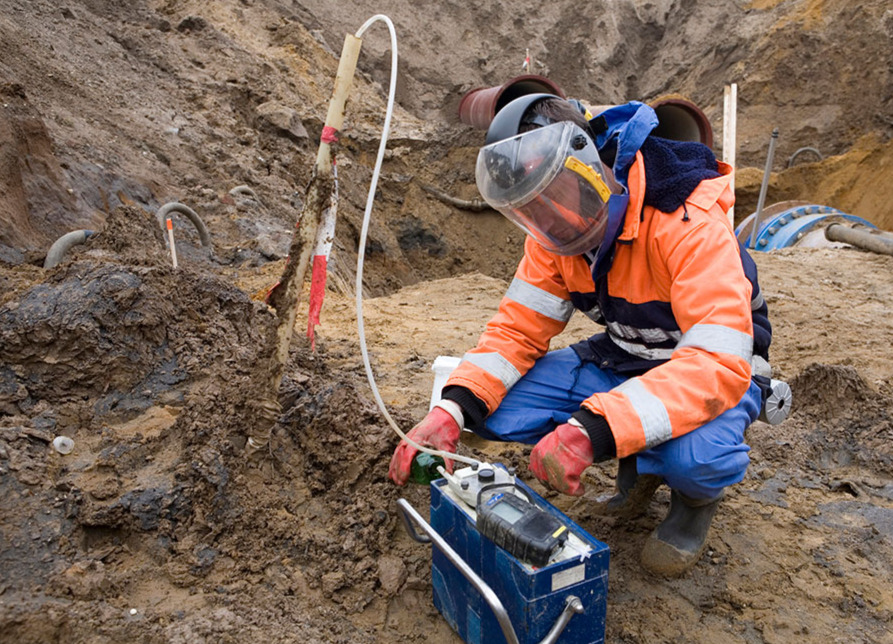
[0,0,893,644]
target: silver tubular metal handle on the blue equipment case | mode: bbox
[397,499,584,644]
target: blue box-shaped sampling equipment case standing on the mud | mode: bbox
[398,472,609,644]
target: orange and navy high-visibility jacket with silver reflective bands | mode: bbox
[447,153,768,458]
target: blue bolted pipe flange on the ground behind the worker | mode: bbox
[735,205,877,251]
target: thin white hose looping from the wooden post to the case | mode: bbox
[356,14,479,465]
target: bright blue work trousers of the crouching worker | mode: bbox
[476,348,761,499]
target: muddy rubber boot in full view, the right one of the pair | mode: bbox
[642,490,723,577]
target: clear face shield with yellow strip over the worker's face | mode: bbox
[475,121,623,255]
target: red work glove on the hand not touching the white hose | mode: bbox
[530,423,593,496]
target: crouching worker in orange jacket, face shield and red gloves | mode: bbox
[389,94,771,576]
